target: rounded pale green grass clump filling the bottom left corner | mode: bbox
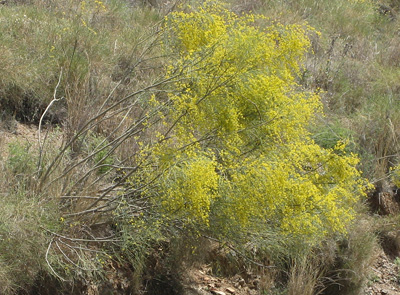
[0,179,58,294]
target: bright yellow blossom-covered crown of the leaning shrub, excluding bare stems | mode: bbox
[128,1,365,241]
